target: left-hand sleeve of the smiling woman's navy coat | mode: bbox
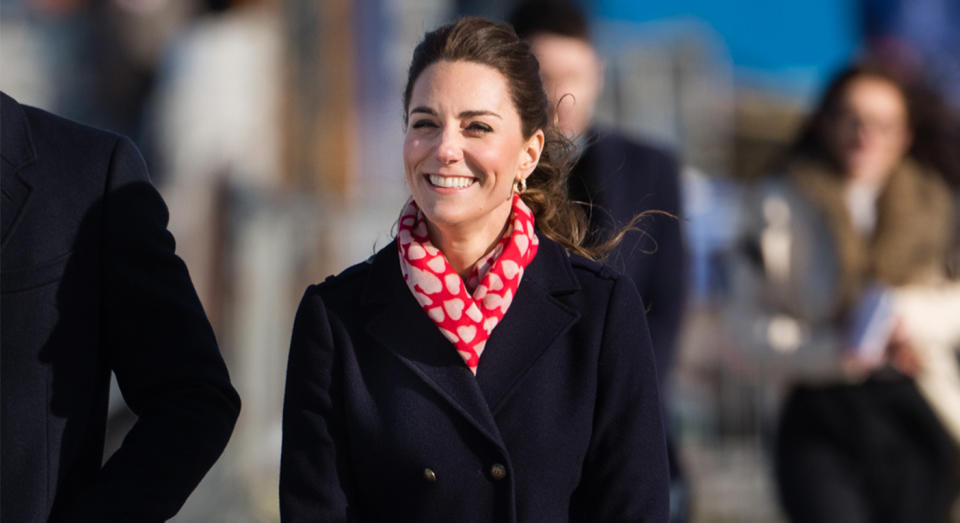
[280,287,349,523]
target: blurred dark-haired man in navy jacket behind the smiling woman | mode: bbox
[510,0,687,521]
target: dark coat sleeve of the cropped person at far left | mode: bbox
[63,139,240,521]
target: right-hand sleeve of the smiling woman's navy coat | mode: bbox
[571,278,670,522]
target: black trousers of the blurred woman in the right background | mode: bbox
[776,375,960,523]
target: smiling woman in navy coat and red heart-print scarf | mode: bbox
[280,18,669,523]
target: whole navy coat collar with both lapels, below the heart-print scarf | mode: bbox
[364,235,580,446]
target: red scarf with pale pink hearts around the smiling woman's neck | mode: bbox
[397,195,540,374]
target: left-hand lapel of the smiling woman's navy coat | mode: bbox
[366,241,504,447]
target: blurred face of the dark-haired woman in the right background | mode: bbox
[826,76,911,182]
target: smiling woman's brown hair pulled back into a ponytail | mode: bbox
[403,17,608,259]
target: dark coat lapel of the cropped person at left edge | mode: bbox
[0,92,36,250]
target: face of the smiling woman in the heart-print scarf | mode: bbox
[403,61,543,231]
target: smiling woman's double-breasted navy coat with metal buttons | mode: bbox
[280,236,669,523]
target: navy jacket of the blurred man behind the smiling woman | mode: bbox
[569,129,687,382]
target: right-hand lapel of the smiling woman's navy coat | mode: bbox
[477,235,580,414]
